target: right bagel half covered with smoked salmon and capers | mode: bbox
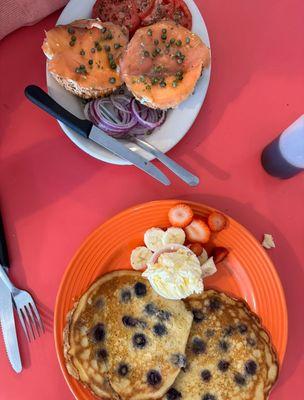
[120,21,210,109]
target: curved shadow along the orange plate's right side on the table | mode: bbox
[181,194,304,387]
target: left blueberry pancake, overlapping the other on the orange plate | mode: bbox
[64,271,193,400]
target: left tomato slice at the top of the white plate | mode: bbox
[92,0,140,34]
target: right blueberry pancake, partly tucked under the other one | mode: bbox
[163,290,278,400]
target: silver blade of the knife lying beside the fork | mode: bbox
[0,270,22,373]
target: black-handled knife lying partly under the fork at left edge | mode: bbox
[0,215,22,373]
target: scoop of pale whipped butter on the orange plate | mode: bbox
[143,249,204,300]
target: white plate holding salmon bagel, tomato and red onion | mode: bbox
[47,0,211,165]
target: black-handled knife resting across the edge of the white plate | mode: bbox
[24,85,170,186]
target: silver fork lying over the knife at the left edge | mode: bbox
[0,264,44,342]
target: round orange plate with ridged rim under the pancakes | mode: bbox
[55,200,287,400]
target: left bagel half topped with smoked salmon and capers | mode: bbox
[42,20,128,99]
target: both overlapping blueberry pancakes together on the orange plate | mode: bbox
[64,271,278,400]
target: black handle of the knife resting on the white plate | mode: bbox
[24,85,92,138]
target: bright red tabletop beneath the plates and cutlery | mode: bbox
[0,0,304,400]
